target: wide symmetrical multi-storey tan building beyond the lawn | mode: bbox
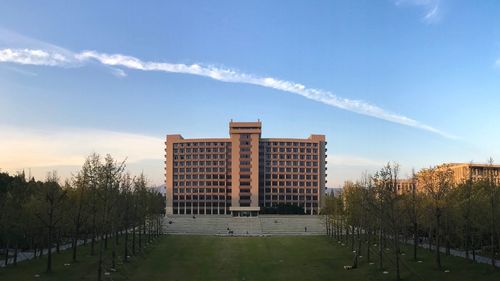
[165,121,327,216]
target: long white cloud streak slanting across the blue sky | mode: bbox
[0,48,456,138]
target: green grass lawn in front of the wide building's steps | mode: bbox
[0,236,500,281]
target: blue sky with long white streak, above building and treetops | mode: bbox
[0,0,500,187]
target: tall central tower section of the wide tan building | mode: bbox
[229,121,262,215]
